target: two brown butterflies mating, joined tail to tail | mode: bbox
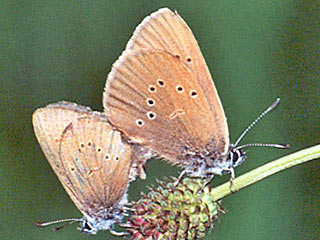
[33,8,283,234]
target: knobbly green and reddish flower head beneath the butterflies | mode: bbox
[128,178,224,240]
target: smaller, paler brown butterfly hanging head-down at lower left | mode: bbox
[32,102,139,235]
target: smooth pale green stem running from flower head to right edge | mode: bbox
[211,145,320,201]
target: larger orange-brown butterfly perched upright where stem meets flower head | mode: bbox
[103,8,285,186]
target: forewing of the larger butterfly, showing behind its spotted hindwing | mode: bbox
[125,8,229,149]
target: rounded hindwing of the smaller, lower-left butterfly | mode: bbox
[60,115,132,216]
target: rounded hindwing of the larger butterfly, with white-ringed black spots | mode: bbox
[104,51,225,163]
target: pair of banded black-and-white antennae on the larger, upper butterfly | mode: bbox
[234,98,289,149]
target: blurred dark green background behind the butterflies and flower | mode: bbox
[0,0,320,240]
